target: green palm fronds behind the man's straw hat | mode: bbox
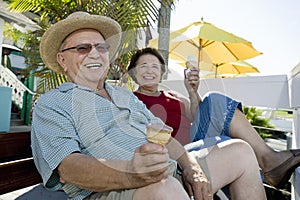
[10,0,173,93]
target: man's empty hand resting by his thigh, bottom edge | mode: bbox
[183,164,213,200]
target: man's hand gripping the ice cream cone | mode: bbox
[127,143,169,187]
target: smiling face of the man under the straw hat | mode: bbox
[58,29,109,87]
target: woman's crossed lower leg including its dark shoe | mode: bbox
[230,110,300,188]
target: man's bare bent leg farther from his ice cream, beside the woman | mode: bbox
[205,139,266,200]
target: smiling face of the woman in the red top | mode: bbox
[134,54,162,86]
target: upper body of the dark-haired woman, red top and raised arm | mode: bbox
[128,48,201,144]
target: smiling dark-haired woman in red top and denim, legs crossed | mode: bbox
[128,48,300,188]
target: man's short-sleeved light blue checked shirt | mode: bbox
[31,82,160,199]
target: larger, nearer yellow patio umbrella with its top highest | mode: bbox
[149,21,261,70]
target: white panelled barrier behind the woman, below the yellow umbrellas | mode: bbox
[162,64,300,200]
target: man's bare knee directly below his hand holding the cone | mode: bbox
[133,176,190,200]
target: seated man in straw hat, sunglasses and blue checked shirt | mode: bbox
[32,12,266,200]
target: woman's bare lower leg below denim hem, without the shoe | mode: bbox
[230,109,291,171]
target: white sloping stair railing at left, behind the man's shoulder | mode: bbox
[0,65,35,125]
